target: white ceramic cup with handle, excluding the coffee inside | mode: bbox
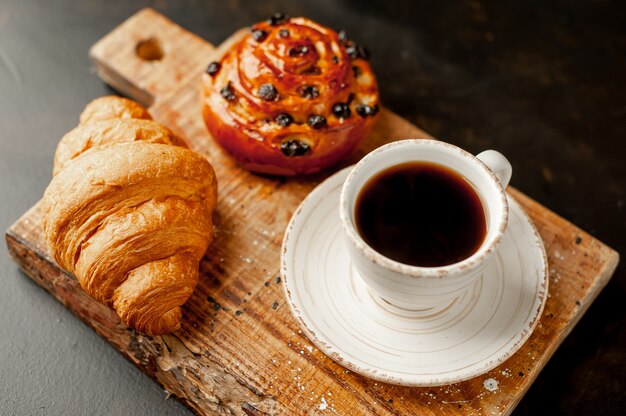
[339,139,512,310]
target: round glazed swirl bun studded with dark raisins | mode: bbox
[202,14,378,175]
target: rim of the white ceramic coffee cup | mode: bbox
[339,139,509,278]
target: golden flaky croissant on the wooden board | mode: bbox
[43,97,217,335]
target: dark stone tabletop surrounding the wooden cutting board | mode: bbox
[0,0,626,415]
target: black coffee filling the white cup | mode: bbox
[354,162,487,267]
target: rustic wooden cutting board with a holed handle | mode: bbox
[6,9,618,415]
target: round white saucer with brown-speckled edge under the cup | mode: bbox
[281,167,548,386]
